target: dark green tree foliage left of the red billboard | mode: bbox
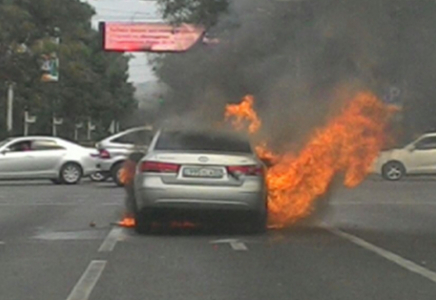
[0,0,136,138]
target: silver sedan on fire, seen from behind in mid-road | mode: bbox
[134,130,267,233]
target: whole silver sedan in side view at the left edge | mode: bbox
[0,136,99,184]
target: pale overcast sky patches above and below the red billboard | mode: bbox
[84,0,159,83]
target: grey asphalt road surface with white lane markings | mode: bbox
[0,179,436,300]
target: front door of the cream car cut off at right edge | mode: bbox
[409,136,436,174]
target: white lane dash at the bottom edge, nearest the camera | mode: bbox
[67,260,107,300]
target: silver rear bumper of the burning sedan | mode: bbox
[135,177,266,213]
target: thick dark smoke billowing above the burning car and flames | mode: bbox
[157,0,436,145]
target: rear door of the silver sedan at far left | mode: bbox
[31,139,67,178]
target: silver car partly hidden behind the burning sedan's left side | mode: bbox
[96,126,153,186]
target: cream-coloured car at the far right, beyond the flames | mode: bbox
[374,133,436,181]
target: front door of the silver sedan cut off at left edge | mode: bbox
[0,140,33,179]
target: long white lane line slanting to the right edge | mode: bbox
[327,228,436,283]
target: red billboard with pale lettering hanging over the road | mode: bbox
[100,22,205,52]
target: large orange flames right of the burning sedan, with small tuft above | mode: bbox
[225,92,393,227]
